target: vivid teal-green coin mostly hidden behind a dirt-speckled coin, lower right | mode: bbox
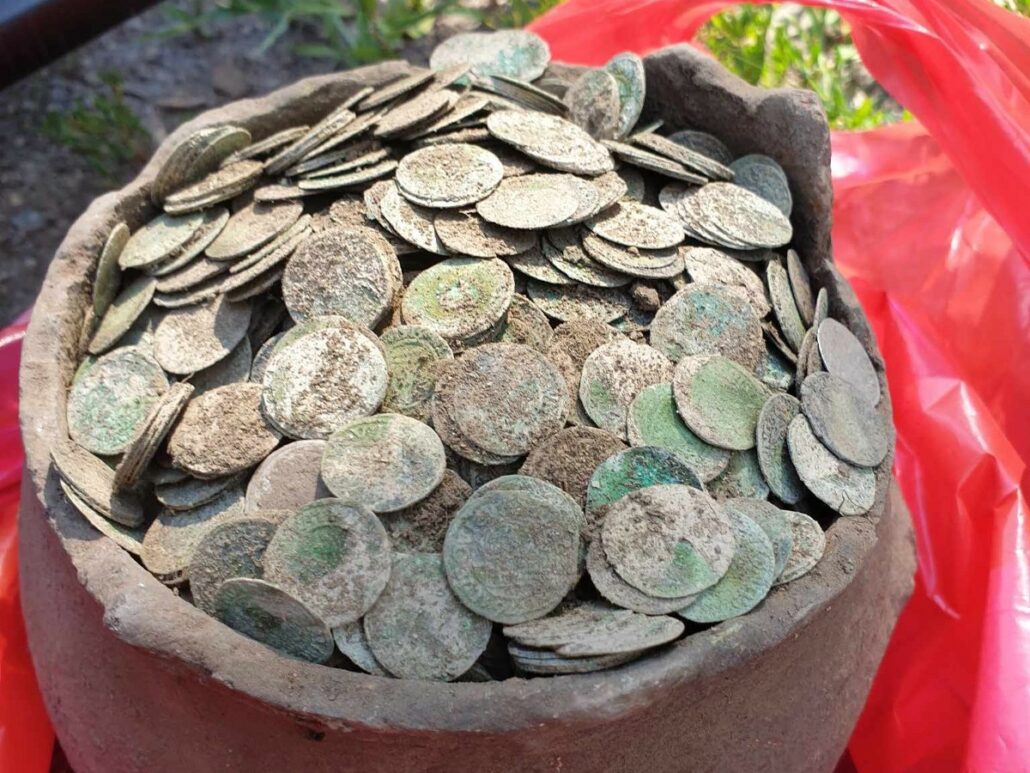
[586,445,702,515]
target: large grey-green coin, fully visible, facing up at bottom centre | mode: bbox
[443,491,580,624]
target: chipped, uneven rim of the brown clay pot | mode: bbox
[21,46,903,732]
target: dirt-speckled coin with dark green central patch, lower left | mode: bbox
[265,499,390,627]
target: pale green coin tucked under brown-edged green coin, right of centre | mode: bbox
[626,383,730,482]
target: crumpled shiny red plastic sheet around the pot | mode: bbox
[0,0,1030,773]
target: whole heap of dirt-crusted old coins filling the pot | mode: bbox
[53,31,892,680]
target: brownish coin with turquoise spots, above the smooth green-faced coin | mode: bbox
[651,283,765,370]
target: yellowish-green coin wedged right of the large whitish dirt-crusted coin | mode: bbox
[380,325,454,422]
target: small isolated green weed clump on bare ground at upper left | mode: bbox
[41,71,150,180]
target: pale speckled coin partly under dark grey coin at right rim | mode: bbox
[787,415,877,515]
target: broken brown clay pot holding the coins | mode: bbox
[20,46,914,773]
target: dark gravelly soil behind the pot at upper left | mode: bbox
[0,1,459,325]
